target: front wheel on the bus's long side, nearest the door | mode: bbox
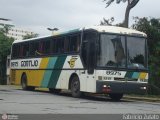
[71,76,82,98]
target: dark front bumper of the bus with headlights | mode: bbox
[96,80,148,94]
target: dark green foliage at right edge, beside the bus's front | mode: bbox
[132,17,160,94]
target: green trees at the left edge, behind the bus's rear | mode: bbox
[0,31,13,84]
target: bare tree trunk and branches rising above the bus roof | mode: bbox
[104,0,139,28]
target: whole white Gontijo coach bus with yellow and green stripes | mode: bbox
[11,26,148,100]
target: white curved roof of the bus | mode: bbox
[13,26,147,43]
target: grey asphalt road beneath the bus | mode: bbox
[0,86,160,119]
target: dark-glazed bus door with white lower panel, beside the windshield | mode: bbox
[81,31,97,92]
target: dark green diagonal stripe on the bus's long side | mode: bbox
[48,56,67,88]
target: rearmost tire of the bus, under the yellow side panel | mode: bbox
[21,74,35,91]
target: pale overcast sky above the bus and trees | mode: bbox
[0,0,160,36]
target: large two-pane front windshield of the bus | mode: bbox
[97,34,147,69]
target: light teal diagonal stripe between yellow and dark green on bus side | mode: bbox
[41,57,57,87]
